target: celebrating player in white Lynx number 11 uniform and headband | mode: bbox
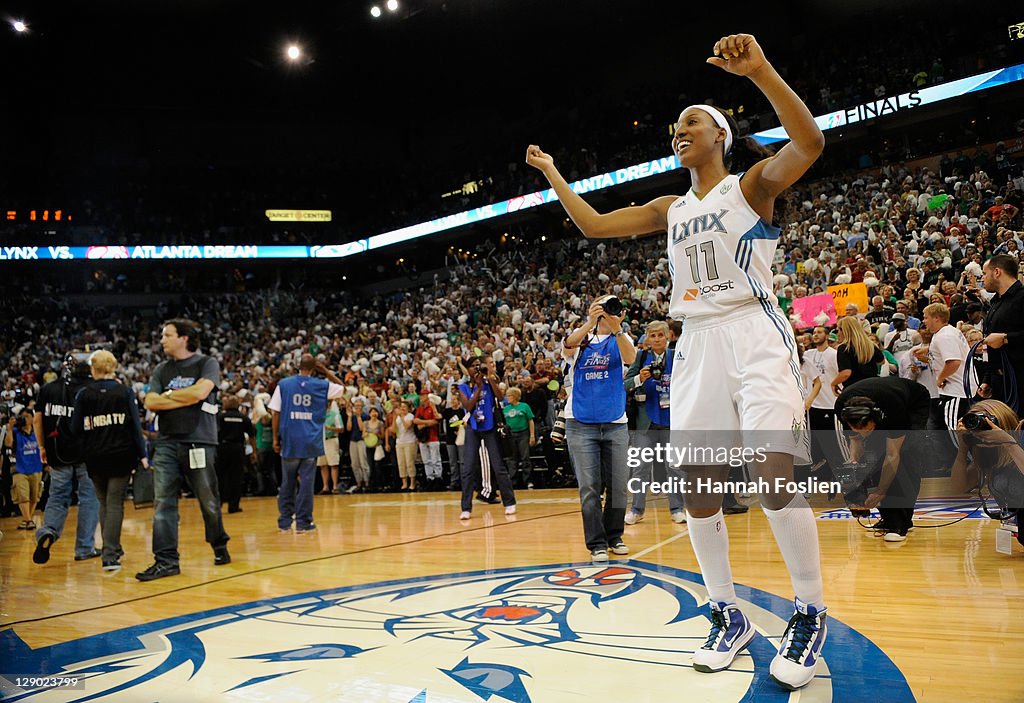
[526,34,826,690]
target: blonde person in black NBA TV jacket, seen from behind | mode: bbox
[72,350,150,571]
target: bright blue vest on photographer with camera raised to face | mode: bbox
[572,335,626,425]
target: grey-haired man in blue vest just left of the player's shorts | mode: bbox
[625,320,686,525]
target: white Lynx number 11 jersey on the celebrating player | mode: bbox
[669,175,780,319]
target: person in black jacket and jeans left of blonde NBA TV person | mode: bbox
[32,351,100,564]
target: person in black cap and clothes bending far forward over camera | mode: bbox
[836,376,931,542]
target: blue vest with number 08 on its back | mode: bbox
[278,376,330,458]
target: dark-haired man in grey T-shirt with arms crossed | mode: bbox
[135,319,231,581]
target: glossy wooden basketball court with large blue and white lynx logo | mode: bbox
[0,479,1024,703]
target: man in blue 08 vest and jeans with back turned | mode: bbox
[270,354,345,532]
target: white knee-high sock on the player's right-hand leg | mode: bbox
[762,493,825,610]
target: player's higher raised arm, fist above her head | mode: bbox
[708,34,825,203]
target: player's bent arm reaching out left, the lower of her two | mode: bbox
[526,144,676,238]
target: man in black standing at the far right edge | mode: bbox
[978,254,1024,402]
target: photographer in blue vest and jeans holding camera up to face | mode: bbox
[562,296,636,562]
